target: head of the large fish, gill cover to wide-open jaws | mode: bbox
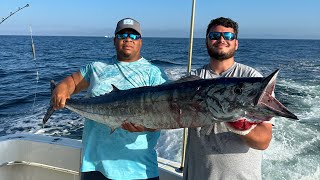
[206,70,298,121]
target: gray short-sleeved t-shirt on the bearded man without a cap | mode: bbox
[184,63,268,180]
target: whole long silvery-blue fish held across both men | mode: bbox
[43,70,298,130]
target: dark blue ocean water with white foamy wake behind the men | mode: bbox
[0,36,320,180]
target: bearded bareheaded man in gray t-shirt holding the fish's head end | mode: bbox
[184,17,272,180]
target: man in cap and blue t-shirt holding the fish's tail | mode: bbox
[52,18,167,180]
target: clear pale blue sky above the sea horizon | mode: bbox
[0,0,320,39]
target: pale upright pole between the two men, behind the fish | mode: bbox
[179,0,196,171]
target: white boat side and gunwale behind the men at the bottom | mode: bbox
[0,134,182,180]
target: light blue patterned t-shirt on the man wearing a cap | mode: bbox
[80,57,167,179]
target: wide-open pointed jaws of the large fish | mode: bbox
[255,69,298,120]
